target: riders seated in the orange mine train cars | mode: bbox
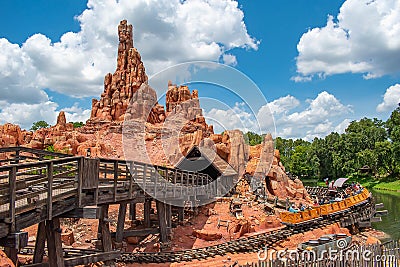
[288,182,364,213]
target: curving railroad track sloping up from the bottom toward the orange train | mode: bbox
[117,202,371,263]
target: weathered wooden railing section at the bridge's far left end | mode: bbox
[0,157,81,232]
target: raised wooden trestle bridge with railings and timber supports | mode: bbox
[0,147,234,266]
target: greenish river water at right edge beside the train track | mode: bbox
[371,190,400,243]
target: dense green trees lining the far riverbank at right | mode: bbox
[275,107,400,183]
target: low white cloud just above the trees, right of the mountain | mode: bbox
[205,91,352,140]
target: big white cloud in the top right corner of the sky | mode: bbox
[292,0,400,82]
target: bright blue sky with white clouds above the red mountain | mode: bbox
[0,0,400,140]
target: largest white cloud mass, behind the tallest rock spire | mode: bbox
[0,0,258,98]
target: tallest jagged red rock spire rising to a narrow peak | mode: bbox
[90,20,165,123]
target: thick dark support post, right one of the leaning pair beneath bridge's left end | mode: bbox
[46,218,64,267]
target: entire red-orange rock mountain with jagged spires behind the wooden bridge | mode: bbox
[0,20,306,203]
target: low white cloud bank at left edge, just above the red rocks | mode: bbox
[0,101,90,130]
